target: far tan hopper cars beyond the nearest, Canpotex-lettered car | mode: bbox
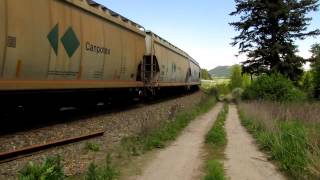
[144,31,200,91]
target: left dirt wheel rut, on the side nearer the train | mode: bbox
[129,103,222,180]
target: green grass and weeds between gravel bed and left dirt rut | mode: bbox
[19,90,216,180]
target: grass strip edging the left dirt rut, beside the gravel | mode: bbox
[82,90,217,180]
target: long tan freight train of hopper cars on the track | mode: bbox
[0,0,200,111]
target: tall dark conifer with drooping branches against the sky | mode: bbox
[230,0,320,81]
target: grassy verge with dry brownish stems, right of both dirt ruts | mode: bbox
[239,102,320,179]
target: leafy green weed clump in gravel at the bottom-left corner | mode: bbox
[19,156,64,180]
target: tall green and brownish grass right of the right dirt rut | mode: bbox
[239,103,320,179]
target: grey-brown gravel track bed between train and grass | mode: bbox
[0,91,203,179]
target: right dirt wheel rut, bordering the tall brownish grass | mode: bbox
[225,105,285,180]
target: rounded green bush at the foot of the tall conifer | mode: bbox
[242,74,305,102]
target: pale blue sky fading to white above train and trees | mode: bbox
[95,0,320,70]
